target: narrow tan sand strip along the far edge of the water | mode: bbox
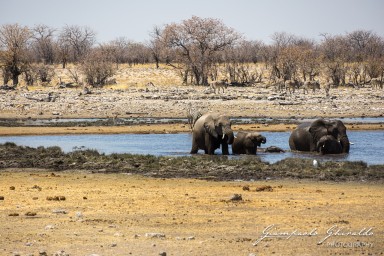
[0,123,384,136]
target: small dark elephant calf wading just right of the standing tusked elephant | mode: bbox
[232,132,267,155]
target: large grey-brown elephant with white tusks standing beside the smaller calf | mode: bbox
[191,113,234,155]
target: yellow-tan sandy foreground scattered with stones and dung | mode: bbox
[0,169,384,255]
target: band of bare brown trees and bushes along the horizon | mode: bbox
[0,16,384,86]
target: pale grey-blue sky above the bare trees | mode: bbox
[0,0,384,43]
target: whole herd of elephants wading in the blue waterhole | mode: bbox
[191,113,350,155]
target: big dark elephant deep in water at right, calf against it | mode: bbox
[289,119,349,153]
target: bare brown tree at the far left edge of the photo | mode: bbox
[0,24,32,86]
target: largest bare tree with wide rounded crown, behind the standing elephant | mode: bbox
[162,16,241,85]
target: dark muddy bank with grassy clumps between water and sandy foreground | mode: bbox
[0,143,384,182]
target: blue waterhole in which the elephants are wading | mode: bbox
[0,131,384,165]
